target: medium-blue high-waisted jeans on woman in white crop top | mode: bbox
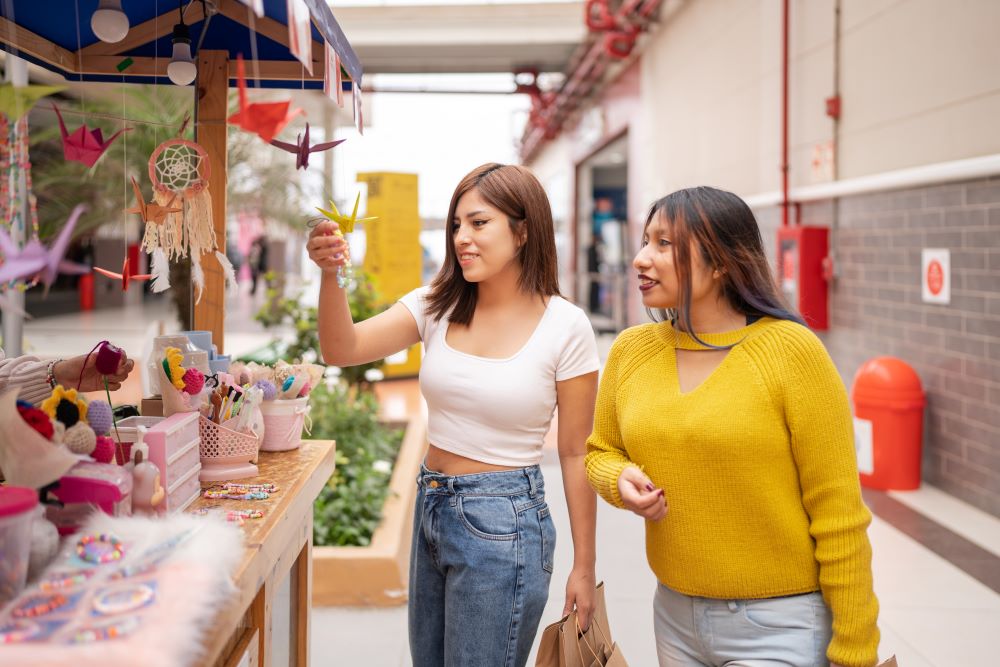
[409,466,556,667]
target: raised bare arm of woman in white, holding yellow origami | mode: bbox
[306,220,420,366]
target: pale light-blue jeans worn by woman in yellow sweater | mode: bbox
[653,584,832,667]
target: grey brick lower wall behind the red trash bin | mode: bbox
[757,178,1000,516]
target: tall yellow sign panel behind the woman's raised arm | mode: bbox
[358,171,423,377]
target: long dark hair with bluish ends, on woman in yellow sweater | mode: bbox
[644,186,805,347]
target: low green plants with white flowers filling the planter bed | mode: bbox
[310,383,402,546]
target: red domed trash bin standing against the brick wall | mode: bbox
[851,357,927,491]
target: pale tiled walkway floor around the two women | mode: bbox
[11,294,1000,667]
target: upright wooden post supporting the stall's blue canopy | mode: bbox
[194,51,229,353]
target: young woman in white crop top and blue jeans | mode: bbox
[307,164,599,667]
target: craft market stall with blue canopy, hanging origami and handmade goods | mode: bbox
[0,0,362,667]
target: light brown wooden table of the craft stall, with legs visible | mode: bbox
[187,440,335,667]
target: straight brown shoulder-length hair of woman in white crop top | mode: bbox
[427,162,559,324]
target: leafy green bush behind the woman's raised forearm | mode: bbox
[254,271,386,391]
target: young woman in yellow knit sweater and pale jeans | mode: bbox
[586,187,879,667]
